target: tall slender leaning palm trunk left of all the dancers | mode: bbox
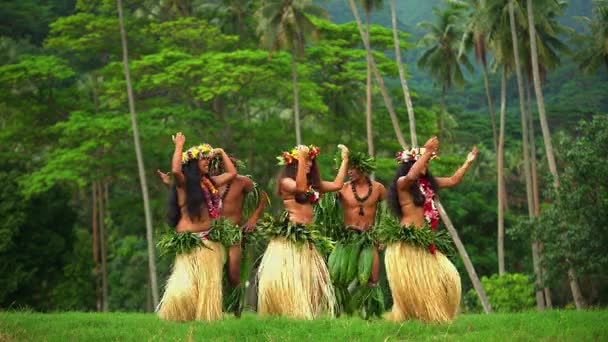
[117,0,158,307]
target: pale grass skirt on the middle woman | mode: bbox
[258,236,336,319]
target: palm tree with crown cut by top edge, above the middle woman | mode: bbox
[256,0,327,145]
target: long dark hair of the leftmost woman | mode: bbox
[167,159,208,227]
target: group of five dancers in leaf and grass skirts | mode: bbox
[158,133,477,322]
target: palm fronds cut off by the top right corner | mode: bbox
[577,0,608,73]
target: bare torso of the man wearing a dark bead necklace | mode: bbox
[338,181,385,230]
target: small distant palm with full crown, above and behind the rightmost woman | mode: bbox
[418,8,473,139]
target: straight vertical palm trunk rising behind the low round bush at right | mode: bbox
[496,65,507,275]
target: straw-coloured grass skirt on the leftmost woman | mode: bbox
[158,240,224,322]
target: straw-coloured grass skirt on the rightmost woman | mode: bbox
[385,242,461,322]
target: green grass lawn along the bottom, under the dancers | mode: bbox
[0,310,608,342]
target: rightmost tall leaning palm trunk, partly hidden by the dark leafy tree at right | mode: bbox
[524,0,587,310]
